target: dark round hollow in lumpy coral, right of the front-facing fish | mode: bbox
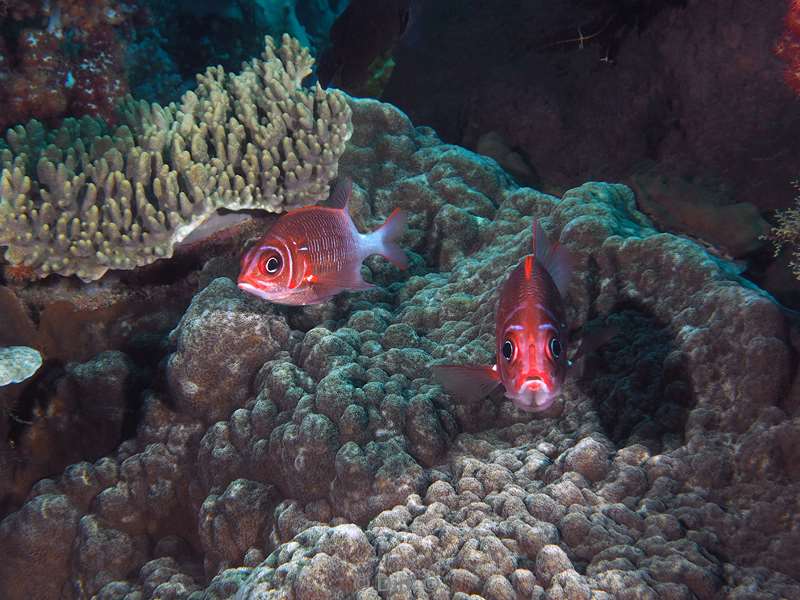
[578,305,694,453]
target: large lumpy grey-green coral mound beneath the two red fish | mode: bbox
[0,99,800,600]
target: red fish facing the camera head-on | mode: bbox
[433,221,572,412]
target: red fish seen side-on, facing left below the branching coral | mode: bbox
[238,179,408,305]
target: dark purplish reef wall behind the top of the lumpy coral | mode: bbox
[382,0,800,210]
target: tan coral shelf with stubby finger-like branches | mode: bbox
[0,35,352,281]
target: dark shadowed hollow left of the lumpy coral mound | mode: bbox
[0,313,179,518]
